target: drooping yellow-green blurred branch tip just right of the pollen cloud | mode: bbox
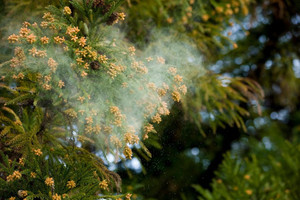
[183,74,264,135]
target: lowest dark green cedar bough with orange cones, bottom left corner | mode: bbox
[0,145,120,200]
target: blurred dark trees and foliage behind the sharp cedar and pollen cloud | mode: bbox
[0,0,300,200]
